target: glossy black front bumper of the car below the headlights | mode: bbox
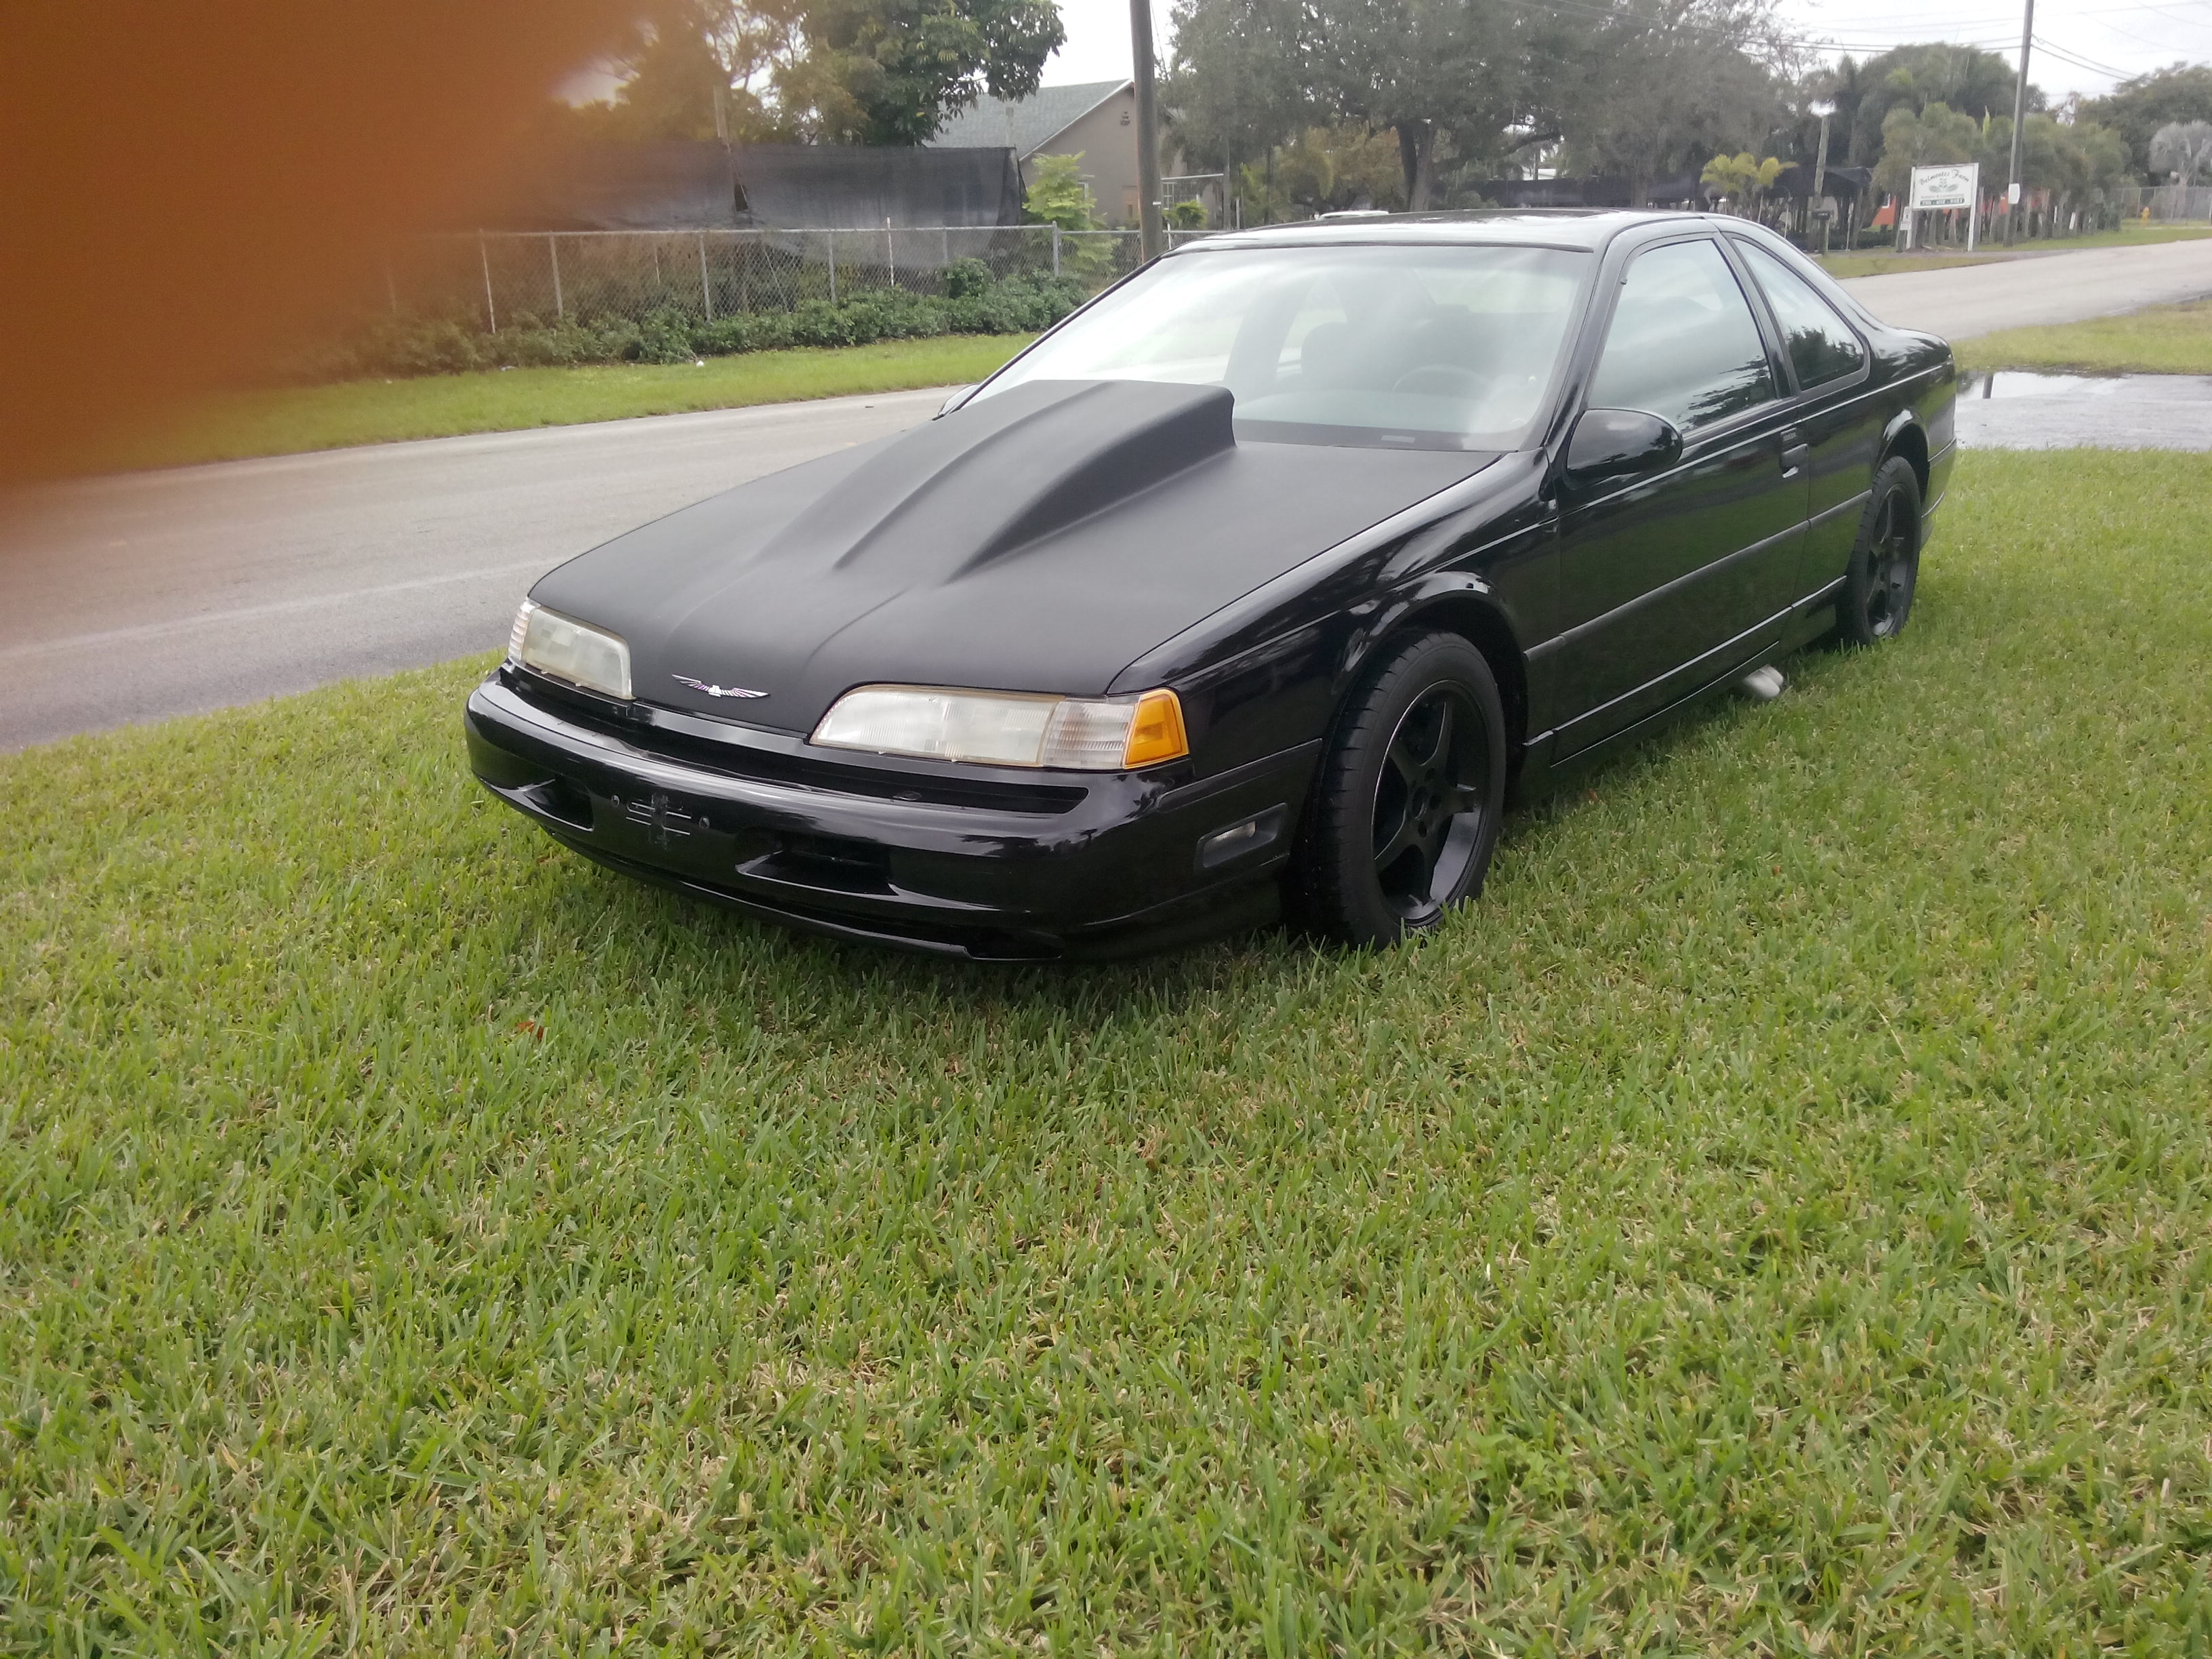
[464,668,1318,960]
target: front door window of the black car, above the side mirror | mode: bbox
[1591,241,1776,431]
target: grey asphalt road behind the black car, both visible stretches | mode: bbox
[0,241,2212,750]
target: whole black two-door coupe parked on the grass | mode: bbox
[467,212,1955,960]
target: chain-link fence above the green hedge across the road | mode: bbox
[363,226,1229,332]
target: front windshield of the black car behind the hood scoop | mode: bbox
[978,245,1589,449]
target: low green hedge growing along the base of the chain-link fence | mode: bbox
[287,273,1090,380]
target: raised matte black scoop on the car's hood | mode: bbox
[763,380,1237,575]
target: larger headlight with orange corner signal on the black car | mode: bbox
[814,686,1190,772]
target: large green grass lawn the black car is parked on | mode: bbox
[0,453,2212,1654]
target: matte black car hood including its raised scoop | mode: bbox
[531,380,1493,732]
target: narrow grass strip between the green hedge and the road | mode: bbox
[104,334,1033,467]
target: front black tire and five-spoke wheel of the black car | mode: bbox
[1294,633,1507,947]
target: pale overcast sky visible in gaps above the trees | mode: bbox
[1044,0,2212,98]
